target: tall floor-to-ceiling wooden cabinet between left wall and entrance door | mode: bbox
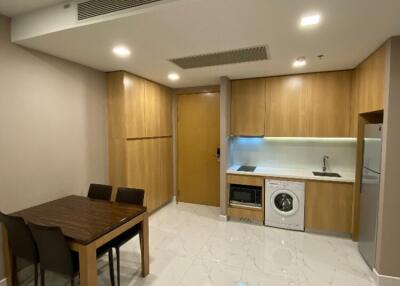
[107,72,173,211]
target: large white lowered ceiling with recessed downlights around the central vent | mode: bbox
[6,0,400,87]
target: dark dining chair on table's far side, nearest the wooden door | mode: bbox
[108,188,144,286]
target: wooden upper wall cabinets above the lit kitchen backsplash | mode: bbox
[231,71,353,137]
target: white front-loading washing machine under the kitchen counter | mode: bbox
[265,179,305,231]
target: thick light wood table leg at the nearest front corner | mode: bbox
[79,243,97,286]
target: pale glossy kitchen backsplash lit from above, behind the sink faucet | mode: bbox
[230,137,356,172]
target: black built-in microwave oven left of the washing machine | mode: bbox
[229,184,262,208]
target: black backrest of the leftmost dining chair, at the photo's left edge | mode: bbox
[0,212,38,263]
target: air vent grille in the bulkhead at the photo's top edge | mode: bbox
[78,0,163,21]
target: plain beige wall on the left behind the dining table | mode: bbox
[0,15,108,279]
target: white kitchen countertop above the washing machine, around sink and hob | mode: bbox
[226,165,355,183]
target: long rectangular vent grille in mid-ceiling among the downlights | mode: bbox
[170,46,268,69]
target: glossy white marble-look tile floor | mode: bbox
[23,203,375,286]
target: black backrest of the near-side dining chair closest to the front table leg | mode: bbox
[28,223,74,277]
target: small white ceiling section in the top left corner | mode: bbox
[0,0,66,17]
